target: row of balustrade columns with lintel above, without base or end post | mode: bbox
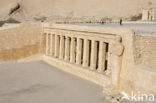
[44,25,115,73]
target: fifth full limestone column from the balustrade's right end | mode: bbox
[70,37,76,63]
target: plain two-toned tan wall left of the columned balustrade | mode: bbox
[0,24,42,61]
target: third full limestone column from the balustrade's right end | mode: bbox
[83,39,89,67]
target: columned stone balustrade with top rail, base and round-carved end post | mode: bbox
[43,23,134,91]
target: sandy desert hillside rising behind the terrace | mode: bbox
[0,0,156,22]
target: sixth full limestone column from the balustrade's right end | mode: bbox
[65,37,70,61]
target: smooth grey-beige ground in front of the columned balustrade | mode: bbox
[0,62,110,103]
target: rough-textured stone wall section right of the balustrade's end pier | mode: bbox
[134,34,156,70]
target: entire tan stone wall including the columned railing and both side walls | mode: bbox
[0,23,156,94]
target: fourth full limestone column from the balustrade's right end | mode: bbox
[76,38,82,64]
